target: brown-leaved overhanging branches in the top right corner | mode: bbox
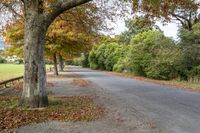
[134,0,200,30]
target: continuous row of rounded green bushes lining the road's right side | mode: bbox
[86,30,193,80]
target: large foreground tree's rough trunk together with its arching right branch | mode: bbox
[19,0,91,107]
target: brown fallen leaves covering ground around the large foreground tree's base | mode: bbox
[0,96,104,131]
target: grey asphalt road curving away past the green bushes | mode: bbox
[70,67,200,133]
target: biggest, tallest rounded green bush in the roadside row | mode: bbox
[127,31,184,79]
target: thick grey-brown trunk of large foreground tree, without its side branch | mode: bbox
[20,1,48,107]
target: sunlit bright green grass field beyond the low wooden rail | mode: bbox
[0,64,50,81]
